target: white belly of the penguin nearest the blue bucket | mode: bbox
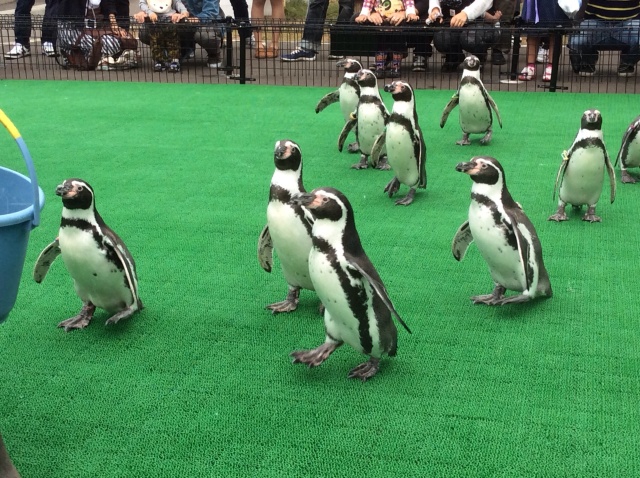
[58,227,133,313]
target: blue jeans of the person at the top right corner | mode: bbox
[569,19,640,71]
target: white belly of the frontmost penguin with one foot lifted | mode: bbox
[309,248,368,352]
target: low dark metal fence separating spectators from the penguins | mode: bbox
[0,15,639,93]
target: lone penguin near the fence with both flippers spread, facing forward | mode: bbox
[440,55,502,146]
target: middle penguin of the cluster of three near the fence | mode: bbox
[338,69,390,170]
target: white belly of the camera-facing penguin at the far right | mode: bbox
[560,145,605,206]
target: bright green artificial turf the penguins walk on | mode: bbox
[0,81,640,478]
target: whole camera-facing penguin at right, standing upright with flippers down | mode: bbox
[549,109,616,222]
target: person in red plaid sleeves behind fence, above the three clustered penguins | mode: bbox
[355,0,418,78]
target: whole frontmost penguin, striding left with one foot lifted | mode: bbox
[290,187,411,381]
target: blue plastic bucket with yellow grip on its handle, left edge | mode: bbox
[0,110,44,323]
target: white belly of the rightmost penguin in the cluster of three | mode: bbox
[385,122,420,187]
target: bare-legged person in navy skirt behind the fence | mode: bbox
[518,0,571,81]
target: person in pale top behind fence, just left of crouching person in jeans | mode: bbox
[135,0,189,73]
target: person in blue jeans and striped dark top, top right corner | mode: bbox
[569,0,640,76]
